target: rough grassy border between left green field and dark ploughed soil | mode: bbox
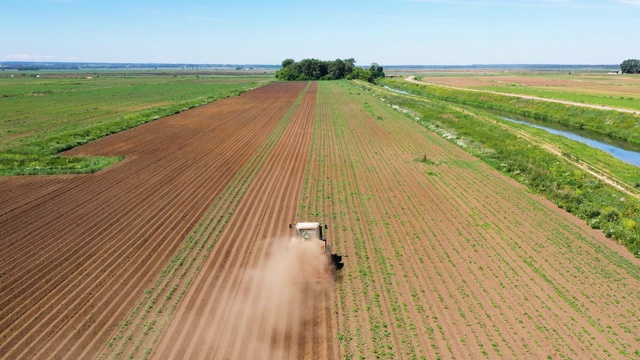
[0,78,272,176]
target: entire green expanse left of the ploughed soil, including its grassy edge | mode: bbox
[0,72,269,175]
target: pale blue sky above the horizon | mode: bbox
[0,0,640,65]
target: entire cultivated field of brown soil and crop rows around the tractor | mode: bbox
[0,81,640,359]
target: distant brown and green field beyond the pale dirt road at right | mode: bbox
[408,72,640,110]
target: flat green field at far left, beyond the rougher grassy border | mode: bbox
[0,74,258,150]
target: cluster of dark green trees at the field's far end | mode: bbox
[276,58,384,82]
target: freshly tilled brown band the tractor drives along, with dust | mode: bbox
[153,84,337,359]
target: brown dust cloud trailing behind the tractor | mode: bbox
[211,239,333,360]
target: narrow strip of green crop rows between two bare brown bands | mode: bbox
[100,82,310,359]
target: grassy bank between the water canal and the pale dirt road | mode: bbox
[378,79,640,145]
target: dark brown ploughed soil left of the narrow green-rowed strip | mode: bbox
[0,83,304,359]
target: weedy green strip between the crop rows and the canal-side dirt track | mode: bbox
[358,81,640,257]
